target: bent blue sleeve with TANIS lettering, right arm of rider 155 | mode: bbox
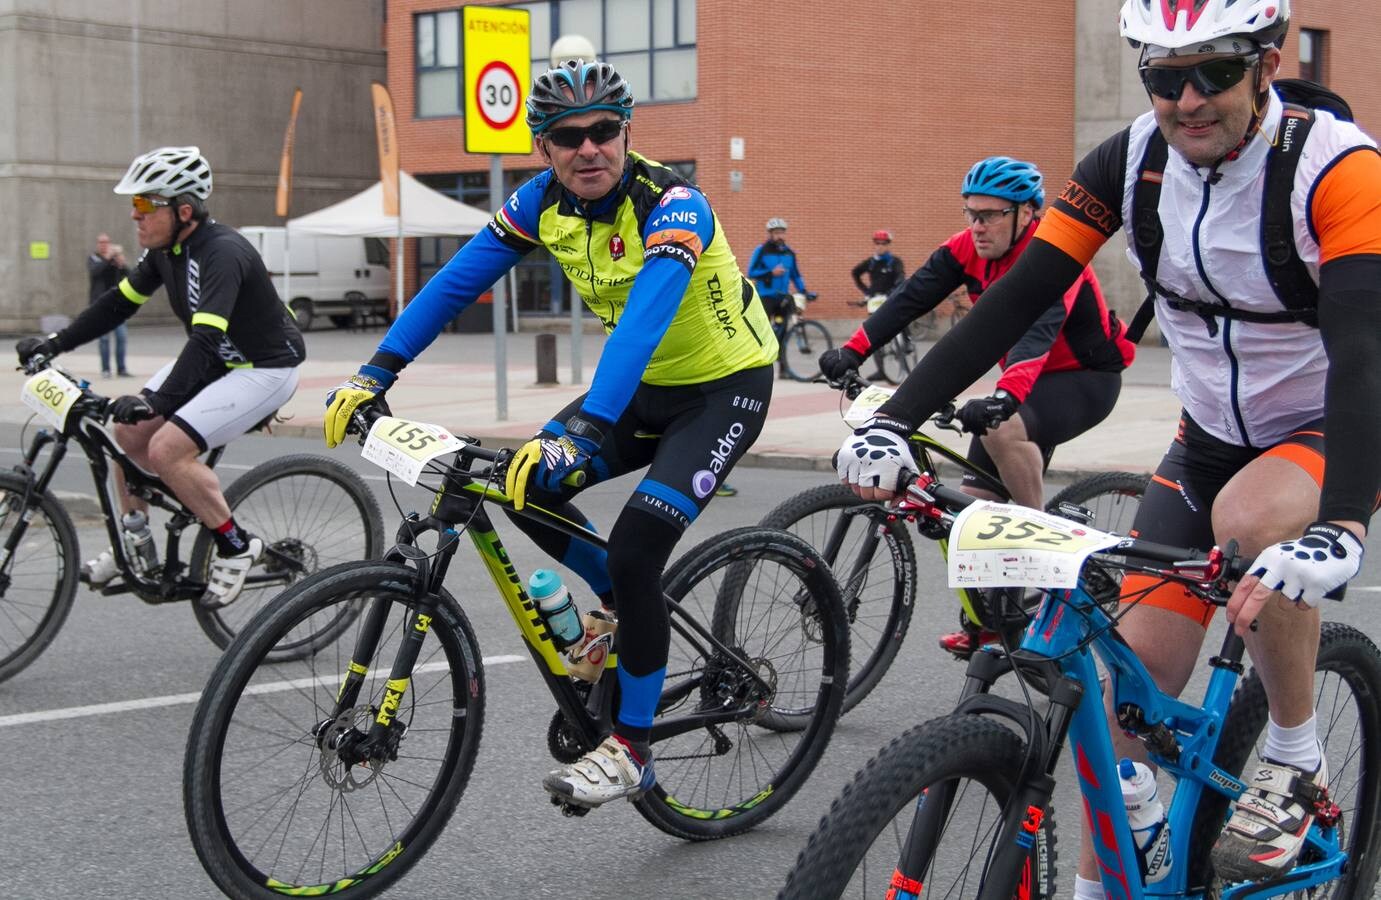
[580,185,714,422]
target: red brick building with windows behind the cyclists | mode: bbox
[385,0,1381,329]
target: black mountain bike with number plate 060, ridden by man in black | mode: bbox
[0,356,384,681]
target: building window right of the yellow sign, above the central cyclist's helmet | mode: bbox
[516,0,696,104]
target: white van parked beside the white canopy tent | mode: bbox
[239,225,394,331]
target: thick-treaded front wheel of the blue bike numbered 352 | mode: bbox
[778,715,1055,900]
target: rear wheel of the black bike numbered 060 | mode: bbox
[191,454,384,658]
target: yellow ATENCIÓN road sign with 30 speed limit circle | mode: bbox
[461,6,532,155]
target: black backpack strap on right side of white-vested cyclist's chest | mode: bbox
[1261,104,1319,327]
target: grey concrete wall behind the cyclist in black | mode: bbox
[0,0,385,331]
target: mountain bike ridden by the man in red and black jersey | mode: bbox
[758,374,1150,712]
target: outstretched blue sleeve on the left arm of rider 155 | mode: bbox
[376,171,550,364]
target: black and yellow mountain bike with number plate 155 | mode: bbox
[184,409,848,897]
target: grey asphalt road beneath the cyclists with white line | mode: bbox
[0,427,1381,900]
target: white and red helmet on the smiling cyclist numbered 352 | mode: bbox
[1121,0,1290,52]
